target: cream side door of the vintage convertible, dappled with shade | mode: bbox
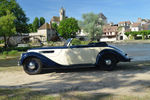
[66,47,96,65]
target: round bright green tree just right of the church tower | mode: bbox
[58,18,79,39]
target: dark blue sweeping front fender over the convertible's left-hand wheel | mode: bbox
[20,52,60,67]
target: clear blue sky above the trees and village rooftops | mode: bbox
[16,0,150,23]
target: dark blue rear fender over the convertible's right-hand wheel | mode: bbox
[96,49,130,64]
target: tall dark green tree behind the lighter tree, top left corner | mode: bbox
[0,0,29,33]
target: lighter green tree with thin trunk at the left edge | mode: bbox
[0,11,16,48]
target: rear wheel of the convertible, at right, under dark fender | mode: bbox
[98,55,117,71]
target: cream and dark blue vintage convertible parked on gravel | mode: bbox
[19,38,130,75]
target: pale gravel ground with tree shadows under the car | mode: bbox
[0,61,150,95]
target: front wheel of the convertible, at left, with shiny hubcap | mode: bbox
[23,58,42,75]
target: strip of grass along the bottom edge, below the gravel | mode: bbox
[0,88,150,100]
